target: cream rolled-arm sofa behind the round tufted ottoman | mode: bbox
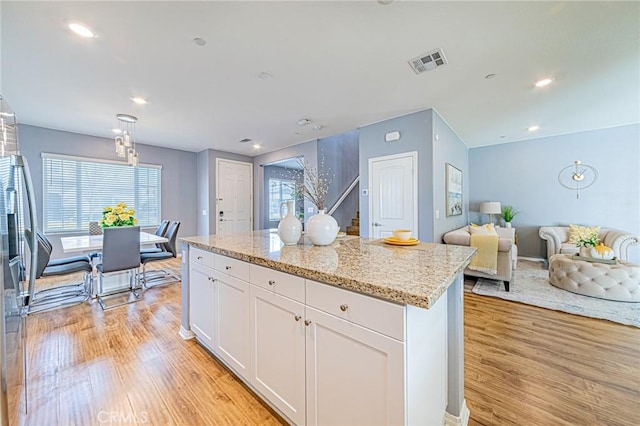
[538,226,640,260]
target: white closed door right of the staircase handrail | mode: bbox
[369,151,418,238]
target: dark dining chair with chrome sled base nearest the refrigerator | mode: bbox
[24,229,93,313]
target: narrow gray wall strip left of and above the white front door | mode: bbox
[196,149,255,235]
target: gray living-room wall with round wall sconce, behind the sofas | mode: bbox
[469,124,640,263]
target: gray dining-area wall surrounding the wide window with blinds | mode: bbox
[18,125,197,258]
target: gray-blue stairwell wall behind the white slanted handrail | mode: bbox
[318,130,360,231]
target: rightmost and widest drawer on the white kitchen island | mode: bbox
[306,280,405,341]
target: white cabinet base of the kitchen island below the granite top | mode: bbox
[189,247,447,425]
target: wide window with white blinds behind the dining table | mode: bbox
[42,153,162,233]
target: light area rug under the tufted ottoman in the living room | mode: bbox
[472,262,640,327]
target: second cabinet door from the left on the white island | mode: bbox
[214,271,251,378]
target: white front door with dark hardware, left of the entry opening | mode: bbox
[216,158,253,235]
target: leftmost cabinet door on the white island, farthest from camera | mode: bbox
[189,264,216,350]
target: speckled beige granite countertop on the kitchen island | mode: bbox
[180,230,475,308]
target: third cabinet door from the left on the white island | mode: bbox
[250,285,305,425]
